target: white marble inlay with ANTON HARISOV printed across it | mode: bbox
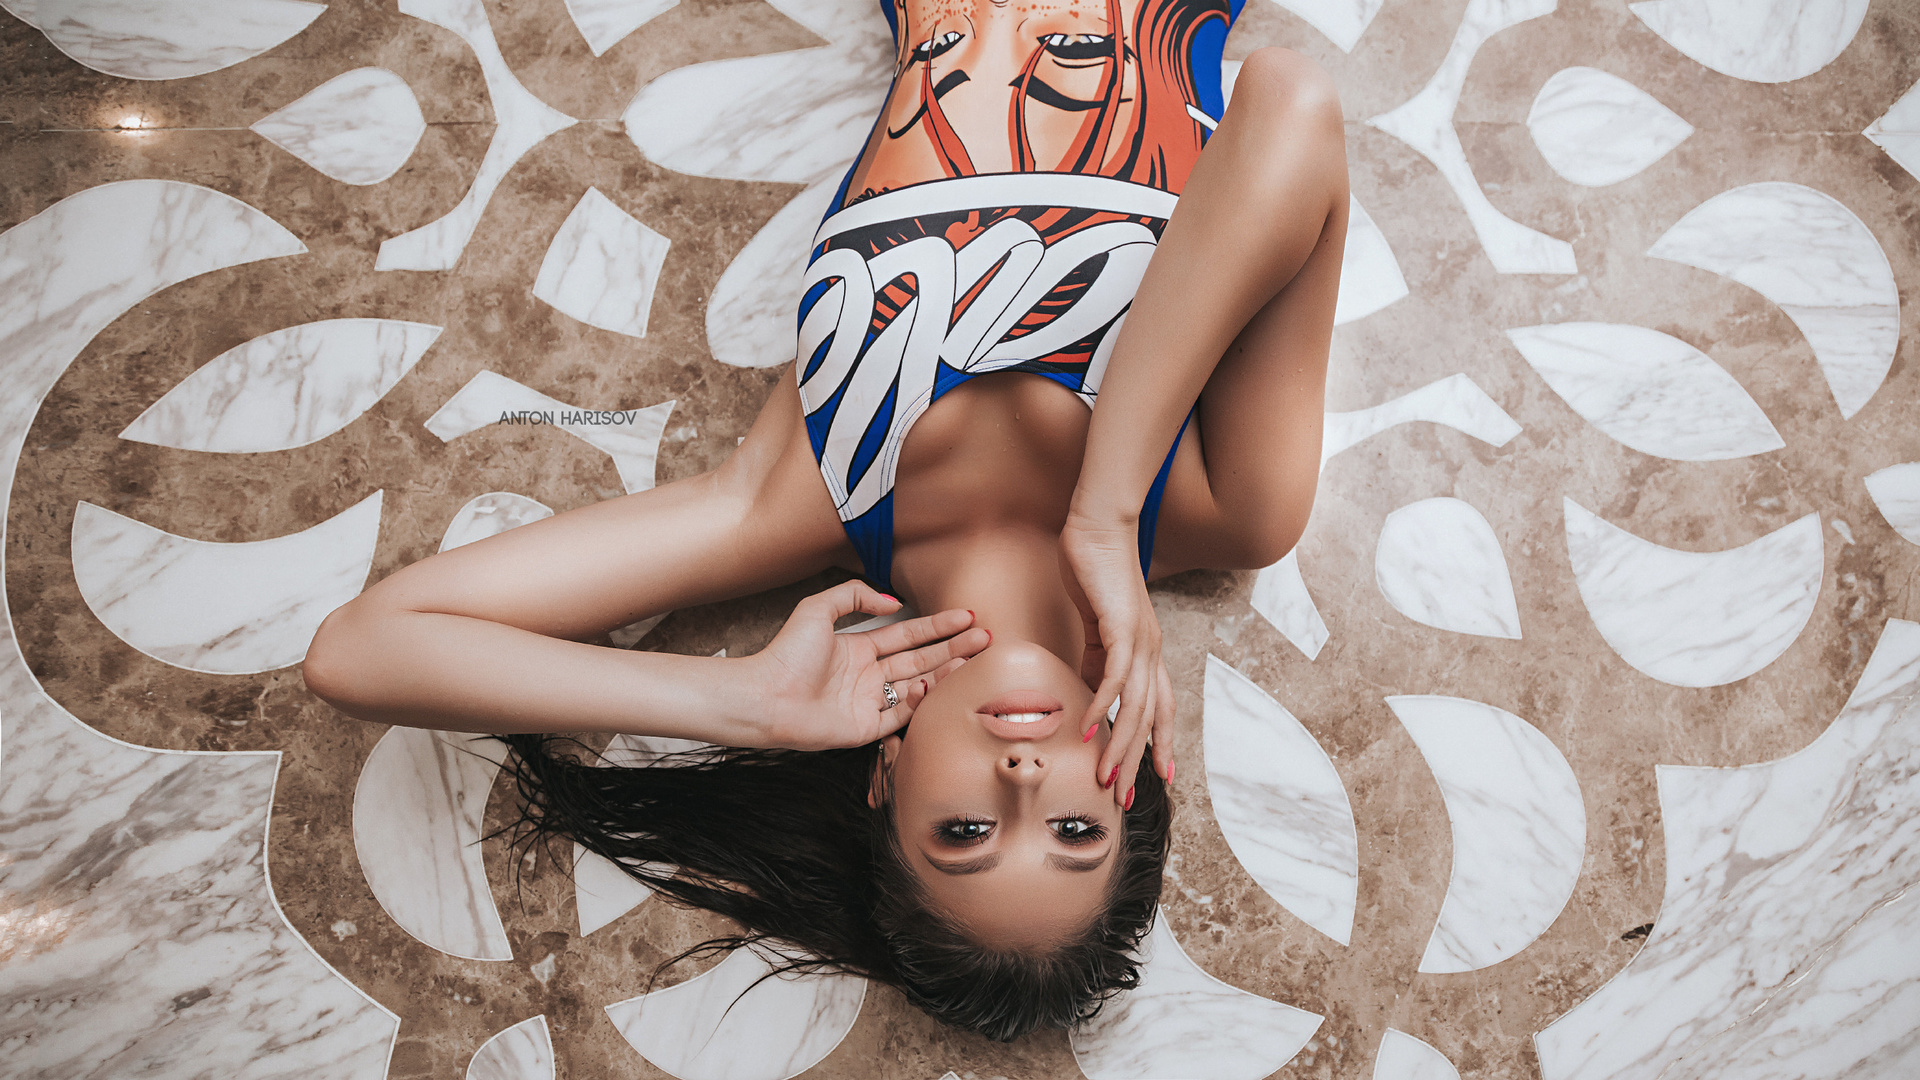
[426,371,674,494]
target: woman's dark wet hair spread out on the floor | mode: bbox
[499,734,1171,1042]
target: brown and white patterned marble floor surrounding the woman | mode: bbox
[0,0,1920,1080]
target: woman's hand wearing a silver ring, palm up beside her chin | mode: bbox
[745,580,991,749]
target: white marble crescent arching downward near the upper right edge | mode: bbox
[1647,181,1901,417]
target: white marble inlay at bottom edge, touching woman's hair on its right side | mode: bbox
[1068,911,1321,1080]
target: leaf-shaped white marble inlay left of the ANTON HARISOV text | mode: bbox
[121,319,442,454]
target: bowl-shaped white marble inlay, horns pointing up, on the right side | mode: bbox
[1563,500,1826,686]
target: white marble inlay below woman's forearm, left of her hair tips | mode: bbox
[353,728,513,961]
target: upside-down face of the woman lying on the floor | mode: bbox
[885,640,1121,947]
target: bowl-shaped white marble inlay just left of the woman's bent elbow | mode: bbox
[73,492,382,675]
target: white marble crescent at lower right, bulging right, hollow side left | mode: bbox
[1386,696,1586,972]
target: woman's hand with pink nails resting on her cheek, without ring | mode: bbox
[1060,515,1173,807]
